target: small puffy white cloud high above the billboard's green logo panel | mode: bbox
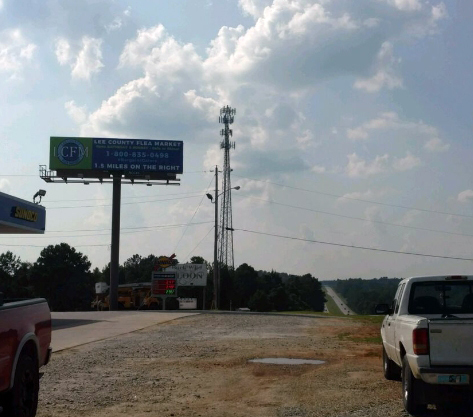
[55,36,104,80]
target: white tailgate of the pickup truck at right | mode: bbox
[429,319,473,366]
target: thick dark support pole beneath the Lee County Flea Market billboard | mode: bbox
[110,174,122,311]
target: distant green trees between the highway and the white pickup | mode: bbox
[325,277,401,314]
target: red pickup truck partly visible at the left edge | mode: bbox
[0,293,51,417]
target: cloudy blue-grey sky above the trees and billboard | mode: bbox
[0,0,473,280]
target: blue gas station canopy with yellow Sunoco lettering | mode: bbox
[0,193,46,234]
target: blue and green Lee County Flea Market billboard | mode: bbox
[49,136,184,176]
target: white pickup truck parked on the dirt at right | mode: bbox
[376,275,473,416]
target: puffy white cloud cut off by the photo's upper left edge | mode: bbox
[0,29,36,78]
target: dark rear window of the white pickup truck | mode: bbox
[408,281,473,315]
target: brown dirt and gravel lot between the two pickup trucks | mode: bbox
[38,314,407,417]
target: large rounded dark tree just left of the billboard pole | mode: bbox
[31,243,94,311]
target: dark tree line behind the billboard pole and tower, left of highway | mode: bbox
[0,243,325,311]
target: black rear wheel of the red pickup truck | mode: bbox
[5,353,39,417]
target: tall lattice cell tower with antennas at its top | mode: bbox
[218,106,236,269]
